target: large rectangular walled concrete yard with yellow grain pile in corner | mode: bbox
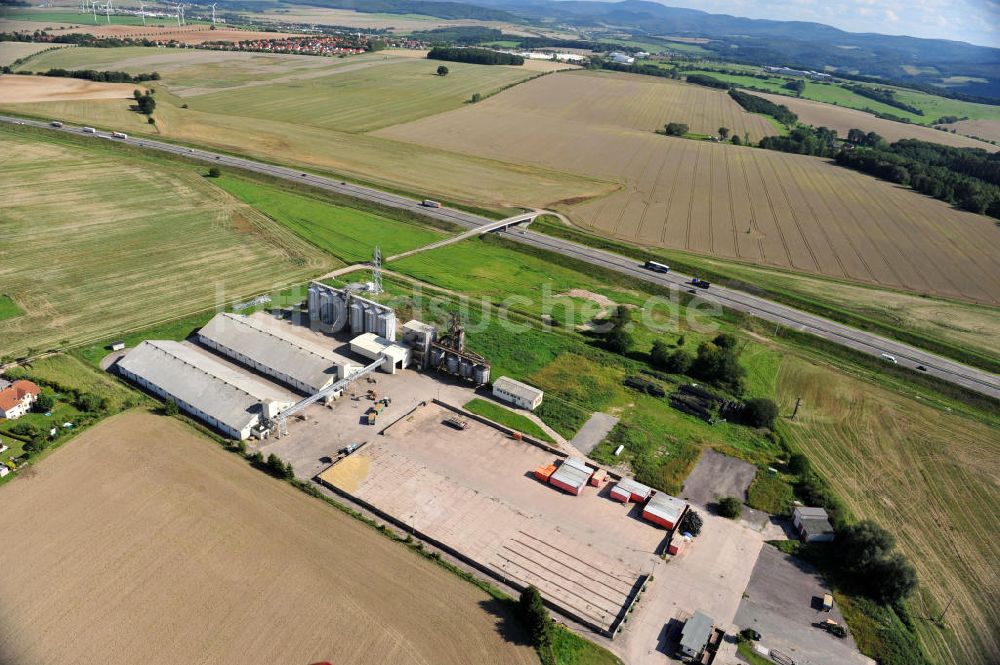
[321,400,668,628]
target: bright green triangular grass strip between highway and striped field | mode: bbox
[213,175,445,263]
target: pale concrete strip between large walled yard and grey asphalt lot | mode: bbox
[615,513,763,663]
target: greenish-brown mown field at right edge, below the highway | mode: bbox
[776,358,1000,665]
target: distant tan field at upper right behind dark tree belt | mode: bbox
[747,90,1000,152]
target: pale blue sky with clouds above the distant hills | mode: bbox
[657,0,1000,47]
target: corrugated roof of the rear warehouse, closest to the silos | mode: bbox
[198,312,337,392]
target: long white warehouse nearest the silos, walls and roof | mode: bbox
[198,312,359,395]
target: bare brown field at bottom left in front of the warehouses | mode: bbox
[0,412,538,665]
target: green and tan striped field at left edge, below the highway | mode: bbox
[0,129,333,354]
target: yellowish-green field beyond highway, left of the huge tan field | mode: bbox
[187,59,537,132]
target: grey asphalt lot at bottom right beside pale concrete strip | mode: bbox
[735,546,873,665]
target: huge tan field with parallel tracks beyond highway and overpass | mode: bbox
[375,73,1000,304]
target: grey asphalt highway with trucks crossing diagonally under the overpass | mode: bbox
[0,115,1000,399]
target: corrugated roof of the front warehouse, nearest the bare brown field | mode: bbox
[118,340,291,431]
